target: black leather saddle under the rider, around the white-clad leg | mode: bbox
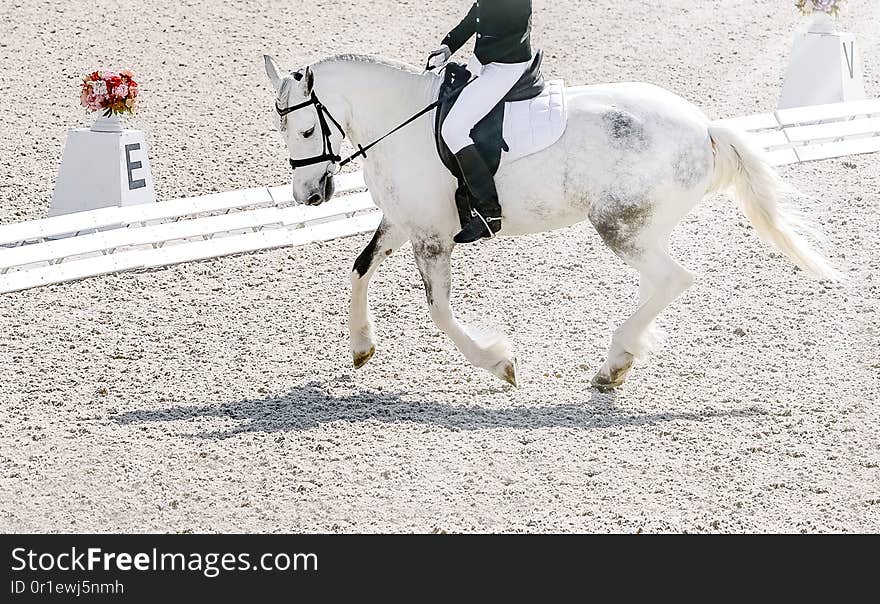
[434,50,545,226]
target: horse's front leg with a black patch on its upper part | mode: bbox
[348,218,407,369]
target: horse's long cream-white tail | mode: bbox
[709,125,840,279]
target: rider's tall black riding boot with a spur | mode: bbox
[454,145,501,243]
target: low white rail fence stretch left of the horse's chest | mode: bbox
[0,173,381,293]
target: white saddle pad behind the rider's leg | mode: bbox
[501,80,568,166]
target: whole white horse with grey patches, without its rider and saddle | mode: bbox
[264,55,836,390]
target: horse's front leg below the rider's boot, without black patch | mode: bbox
[413,238,517,386]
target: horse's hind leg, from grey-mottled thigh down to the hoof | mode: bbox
[590,202,694,390]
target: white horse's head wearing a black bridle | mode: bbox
[263,55,343,206]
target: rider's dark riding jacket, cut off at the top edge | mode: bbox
[443,0,532,65]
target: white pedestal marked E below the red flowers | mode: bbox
[49,120,156,216]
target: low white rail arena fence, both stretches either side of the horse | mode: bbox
[0,99,880,293]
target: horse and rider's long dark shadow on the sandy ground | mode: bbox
[113,382,763,439]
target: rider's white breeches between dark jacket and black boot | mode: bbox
[440,57,532,153]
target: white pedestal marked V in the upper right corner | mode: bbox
[778,16,865,109]
